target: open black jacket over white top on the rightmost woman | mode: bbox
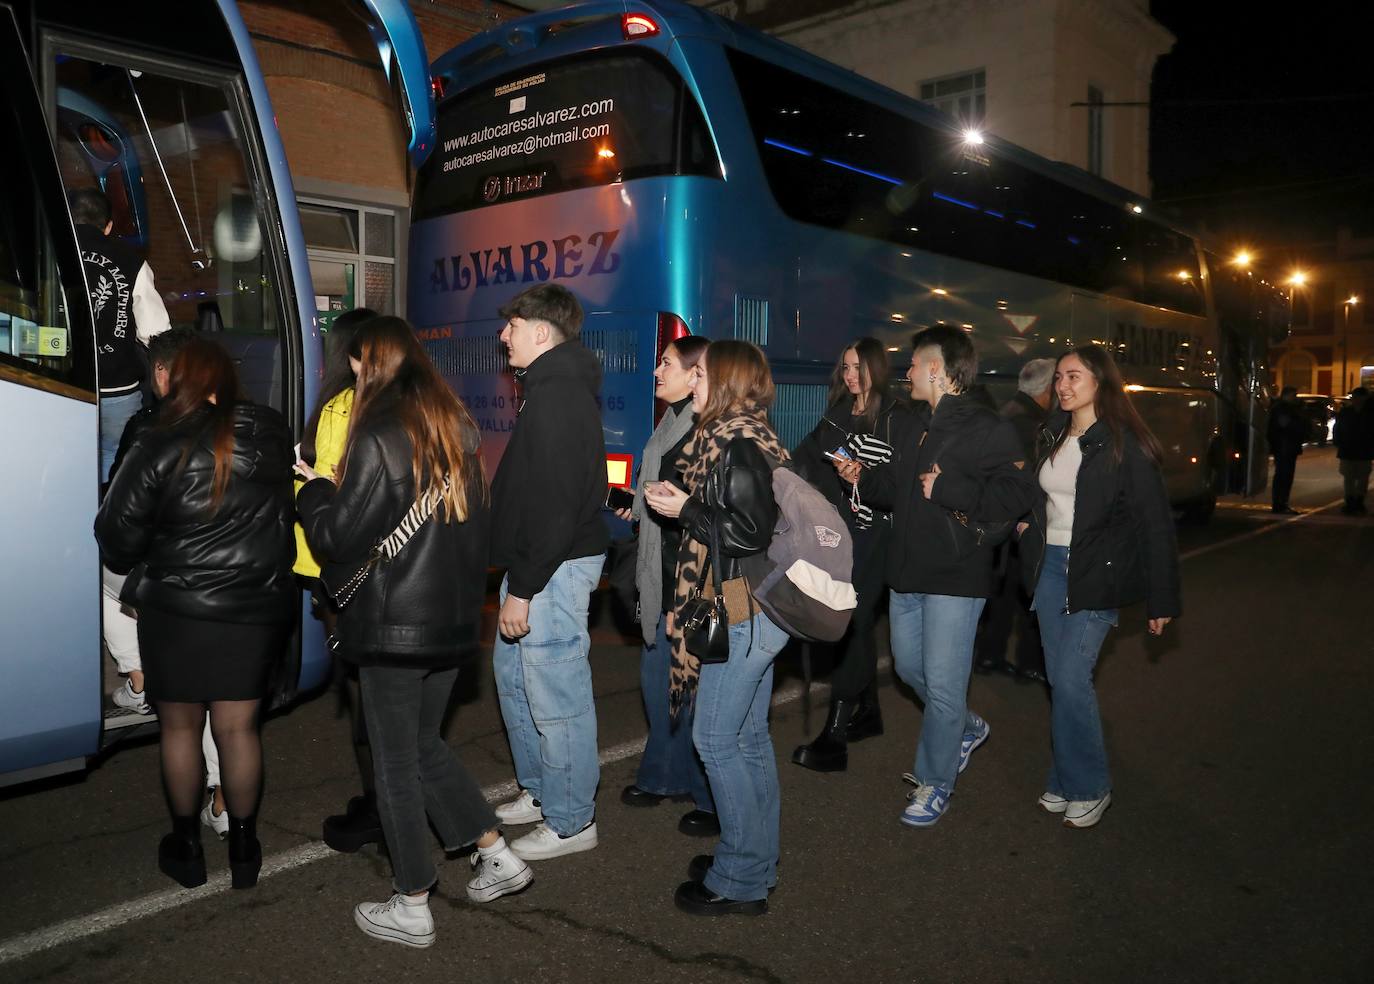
[1021,410,1183,618]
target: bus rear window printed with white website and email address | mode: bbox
[415,51,720,220]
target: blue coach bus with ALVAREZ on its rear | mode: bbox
[409,0,1286,515]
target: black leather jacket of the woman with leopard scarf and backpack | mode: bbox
[679,437,778,581]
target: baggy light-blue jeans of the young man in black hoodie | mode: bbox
[492,554,606,836]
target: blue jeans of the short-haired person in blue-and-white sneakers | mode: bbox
[888,591,987,793]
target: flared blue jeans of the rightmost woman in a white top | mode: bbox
[1032,547,1117,800]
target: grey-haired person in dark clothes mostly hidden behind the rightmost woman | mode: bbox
[973,359,1054,683]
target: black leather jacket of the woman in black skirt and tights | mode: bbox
[95,403,297,624]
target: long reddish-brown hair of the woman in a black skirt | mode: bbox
[158,338,239,515]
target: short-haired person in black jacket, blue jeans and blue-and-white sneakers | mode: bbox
[859,326,1035,827]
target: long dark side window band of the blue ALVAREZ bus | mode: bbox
[728,49,1201,312]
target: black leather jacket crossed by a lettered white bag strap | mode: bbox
[297,408,491,669]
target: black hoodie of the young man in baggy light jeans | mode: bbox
[492,341,610,599]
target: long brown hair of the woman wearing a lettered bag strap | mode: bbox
[338,316,486,522]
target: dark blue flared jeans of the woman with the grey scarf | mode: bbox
[635,612,716,814]
